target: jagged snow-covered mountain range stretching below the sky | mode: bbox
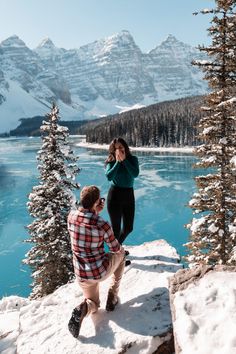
[0,31,207,132]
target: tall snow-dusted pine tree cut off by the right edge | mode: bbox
[187,0,236,265]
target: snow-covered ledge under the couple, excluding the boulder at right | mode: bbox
[0,240,182,354]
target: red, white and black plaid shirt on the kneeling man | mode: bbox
[68,209,121,280]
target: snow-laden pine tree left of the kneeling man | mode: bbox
[24,105,79,298]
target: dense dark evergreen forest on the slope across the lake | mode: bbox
[78,96,203,147]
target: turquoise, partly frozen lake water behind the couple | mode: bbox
[0,137,199,298]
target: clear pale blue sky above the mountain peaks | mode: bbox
[0,0,215,52]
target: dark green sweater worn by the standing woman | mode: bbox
[106,155,139,188]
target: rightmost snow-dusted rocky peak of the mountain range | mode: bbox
[145,35,206,101]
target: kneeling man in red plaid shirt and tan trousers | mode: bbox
[68,186,125,338]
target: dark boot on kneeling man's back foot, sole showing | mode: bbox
[68,300,88,338]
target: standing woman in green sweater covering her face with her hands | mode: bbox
[105,138,139,244]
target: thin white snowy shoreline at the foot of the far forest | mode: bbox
[76,141,194,153]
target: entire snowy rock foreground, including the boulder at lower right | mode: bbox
[0,240,236,354]
